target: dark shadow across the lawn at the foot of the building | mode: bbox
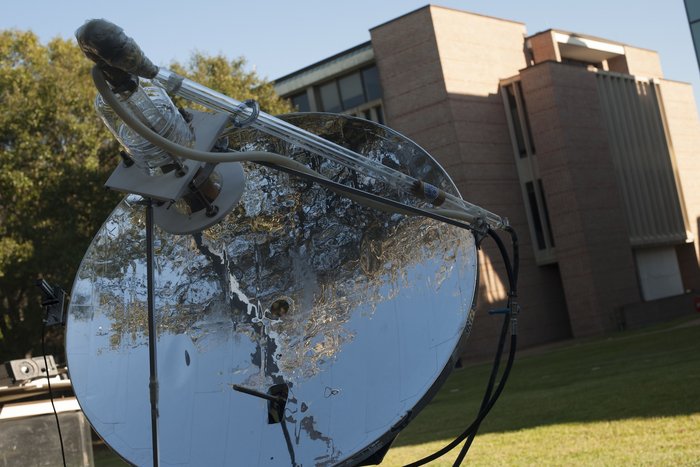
[395,318,700,446]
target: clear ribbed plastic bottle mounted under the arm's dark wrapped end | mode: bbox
[95,79,194,175]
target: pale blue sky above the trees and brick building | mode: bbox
[0,0,700,105]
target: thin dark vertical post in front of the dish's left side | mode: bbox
[146,198,160,467]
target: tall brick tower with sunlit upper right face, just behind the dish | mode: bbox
[371,6,570,356]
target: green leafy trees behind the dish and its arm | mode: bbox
[0,31,290,362]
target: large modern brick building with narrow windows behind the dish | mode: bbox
[276,6,700,355]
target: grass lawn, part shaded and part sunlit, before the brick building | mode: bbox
[382,320,700,466]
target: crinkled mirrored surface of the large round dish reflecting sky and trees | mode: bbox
[66,114,477,466]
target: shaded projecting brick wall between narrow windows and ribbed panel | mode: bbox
[521,62,640,337]
